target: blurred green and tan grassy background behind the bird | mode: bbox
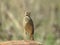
[0,0,60,45]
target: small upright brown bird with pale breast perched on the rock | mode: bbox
[23,12,34,40]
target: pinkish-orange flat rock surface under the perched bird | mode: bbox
[0,40,42,45]
